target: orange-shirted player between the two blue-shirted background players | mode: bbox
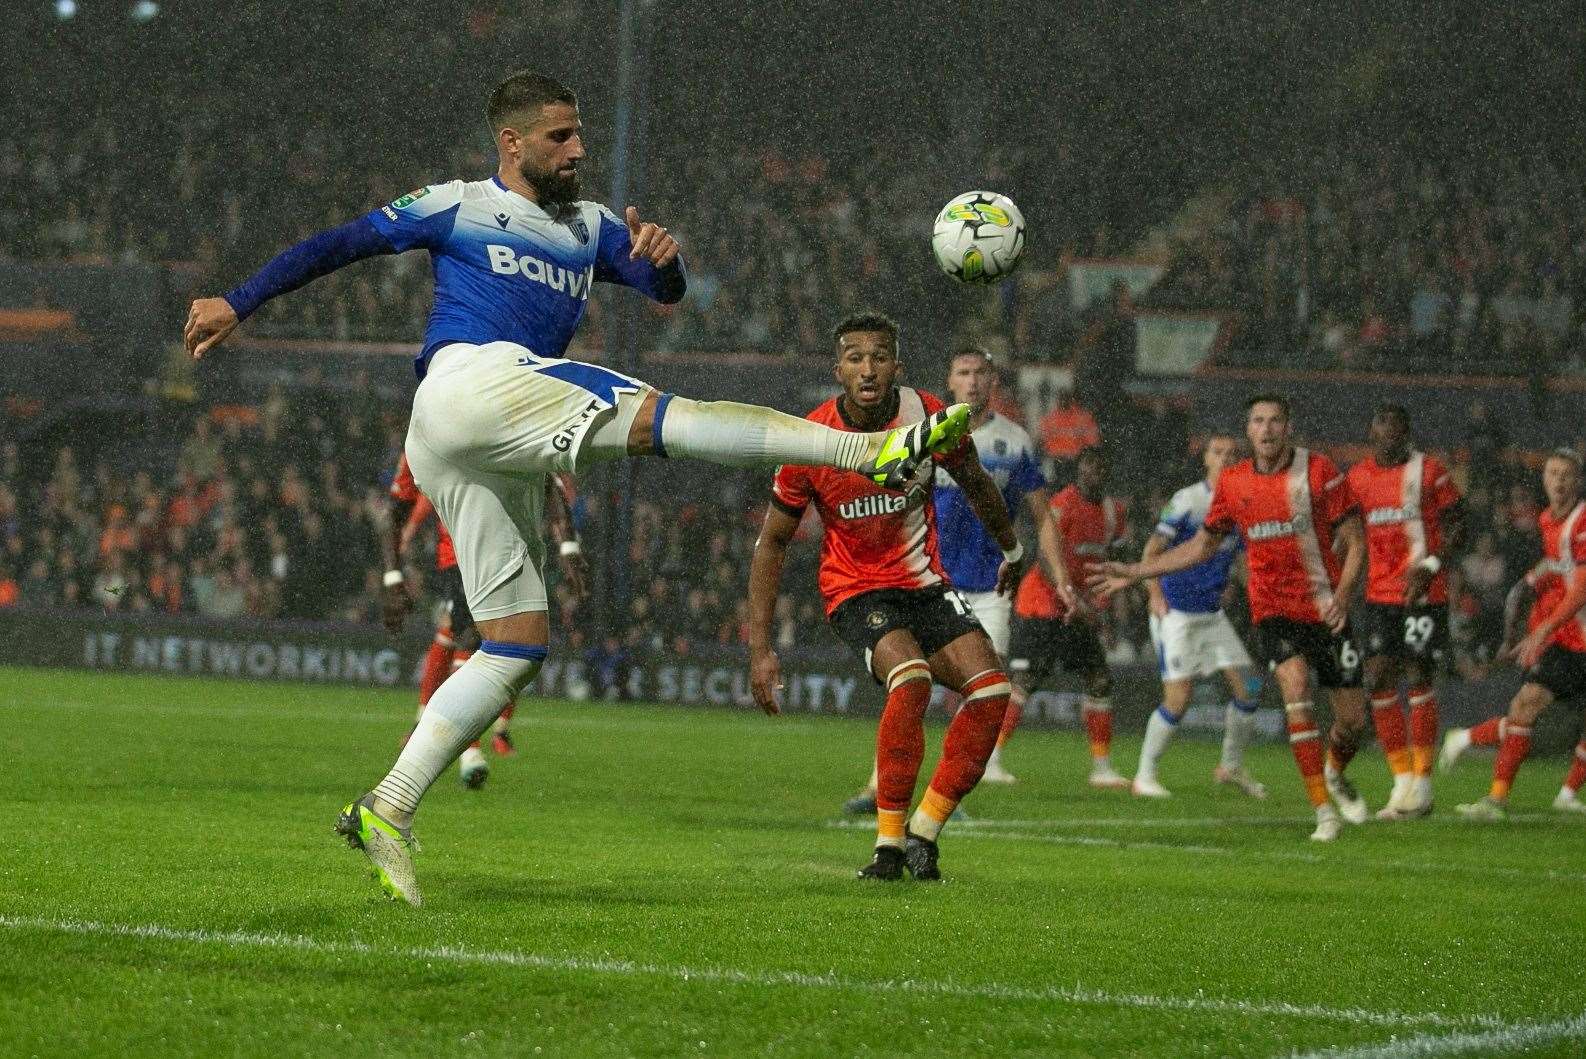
[1007,447,1129,789]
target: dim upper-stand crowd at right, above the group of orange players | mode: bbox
[1145,149,1586,374]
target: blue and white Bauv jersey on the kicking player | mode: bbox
[366,176,680,377]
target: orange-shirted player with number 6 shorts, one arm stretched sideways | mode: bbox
[1090,393,1367,842]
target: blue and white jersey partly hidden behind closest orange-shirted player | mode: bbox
[934,412,1047,591]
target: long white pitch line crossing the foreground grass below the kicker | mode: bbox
[0,915,1508,1030]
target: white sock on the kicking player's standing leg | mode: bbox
[374,640,546,828]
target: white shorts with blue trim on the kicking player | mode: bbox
[404,342,649,620]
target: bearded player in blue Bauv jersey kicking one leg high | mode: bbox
[184,71,969,904]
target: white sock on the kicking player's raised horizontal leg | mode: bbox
[655,395,890,471]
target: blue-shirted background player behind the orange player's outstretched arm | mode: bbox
[1132,434,1267,797]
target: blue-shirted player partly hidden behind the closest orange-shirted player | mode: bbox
[842,346,1048,815]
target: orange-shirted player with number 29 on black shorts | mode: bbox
[1350,404,1462,820]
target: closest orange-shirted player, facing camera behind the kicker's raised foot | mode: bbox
[749,314,1023,880]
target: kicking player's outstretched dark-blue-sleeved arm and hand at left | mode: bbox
[182,181,462,360]
